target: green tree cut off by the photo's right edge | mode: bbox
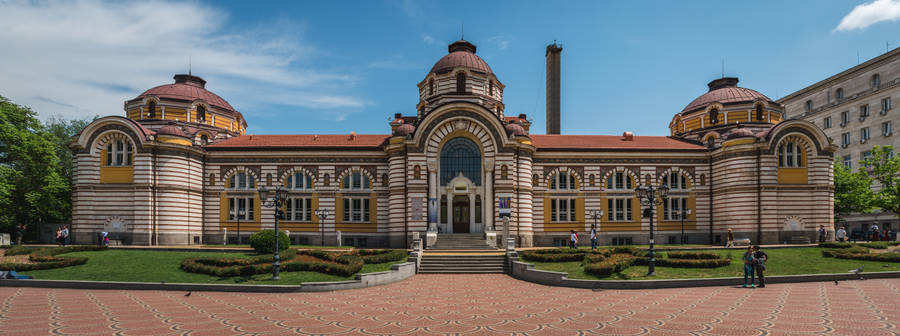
[860,146,900,222]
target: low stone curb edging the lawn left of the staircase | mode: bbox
[0,262,416,293]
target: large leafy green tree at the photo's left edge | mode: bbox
[0,96,71,239]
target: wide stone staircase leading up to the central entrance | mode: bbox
[419,234,506,274]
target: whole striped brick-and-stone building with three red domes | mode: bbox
[72,40,835,247]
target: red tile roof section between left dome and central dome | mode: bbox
[207,134,391,149]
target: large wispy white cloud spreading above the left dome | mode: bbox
[0,0,368,121]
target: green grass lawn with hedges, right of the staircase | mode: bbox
[523,247,900,280]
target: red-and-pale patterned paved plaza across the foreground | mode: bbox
[0,274,900,336]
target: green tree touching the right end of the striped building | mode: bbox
[834,162,875,221]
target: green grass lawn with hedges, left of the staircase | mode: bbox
[22,250,405,285]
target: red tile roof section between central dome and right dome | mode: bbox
[530,134,706,151]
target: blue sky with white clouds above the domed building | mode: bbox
[0,0,900,135]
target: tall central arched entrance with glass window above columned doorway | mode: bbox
[438,137,484,233]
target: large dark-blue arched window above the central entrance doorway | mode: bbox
[440,137,481,185]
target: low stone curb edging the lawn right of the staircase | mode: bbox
[509,261,900,289]
